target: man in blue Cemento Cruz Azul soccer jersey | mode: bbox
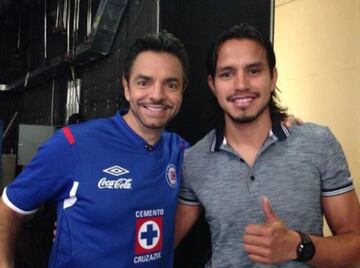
[0,32,188,268]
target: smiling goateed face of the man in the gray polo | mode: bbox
[208,39,277,123]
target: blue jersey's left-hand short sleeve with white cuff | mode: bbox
[2,130,75,215]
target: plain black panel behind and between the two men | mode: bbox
[160,0,273,268]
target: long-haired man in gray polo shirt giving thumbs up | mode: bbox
[175,24,360,268]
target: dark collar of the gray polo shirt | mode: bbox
[210,120,290,152]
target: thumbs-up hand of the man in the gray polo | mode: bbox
[243,197,300,264]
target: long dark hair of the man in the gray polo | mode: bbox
[206,23,287,120]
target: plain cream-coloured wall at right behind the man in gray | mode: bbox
[274,0,360,233]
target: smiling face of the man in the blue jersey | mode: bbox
[123,51,184,137]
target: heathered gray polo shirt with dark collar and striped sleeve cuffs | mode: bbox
[179,123,354,268]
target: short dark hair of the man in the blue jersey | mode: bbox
[124,30,189,86]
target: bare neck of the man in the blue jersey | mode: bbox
[123,112,164,145]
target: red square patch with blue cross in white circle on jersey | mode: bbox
[135,216,163,255]
